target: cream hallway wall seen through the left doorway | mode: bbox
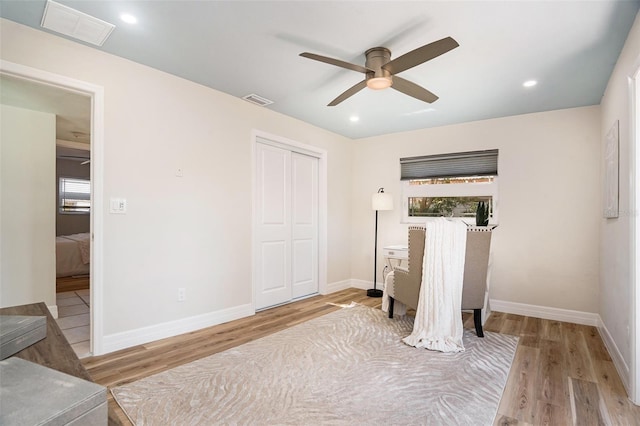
[0,105,56,307]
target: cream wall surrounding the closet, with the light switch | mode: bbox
[0,20,352,335]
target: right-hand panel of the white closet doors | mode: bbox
[291,153,318,299]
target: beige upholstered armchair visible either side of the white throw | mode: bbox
[387,226,492,337]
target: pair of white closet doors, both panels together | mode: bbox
[254,143,319,309]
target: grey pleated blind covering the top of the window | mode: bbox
[400,149,498,180]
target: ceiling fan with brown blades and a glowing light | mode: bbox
[300,37,459,106]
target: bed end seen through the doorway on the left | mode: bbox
[56,232,91,277]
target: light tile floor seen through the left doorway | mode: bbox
[56,290,91,358]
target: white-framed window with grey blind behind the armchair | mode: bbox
[400,150,498,223]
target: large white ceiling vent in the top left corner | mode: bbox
[40,0,116,46]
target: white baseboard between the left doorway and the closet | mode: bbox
[102,303,255,354]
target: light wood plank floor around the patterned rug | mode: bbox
[82,289,640,425]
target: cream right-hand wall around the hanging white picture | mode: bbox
[599,10,640,390]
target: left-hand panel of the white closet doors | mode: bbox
[255,144,292,309]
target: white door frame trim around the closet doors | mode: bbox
[251,129,328,312]
